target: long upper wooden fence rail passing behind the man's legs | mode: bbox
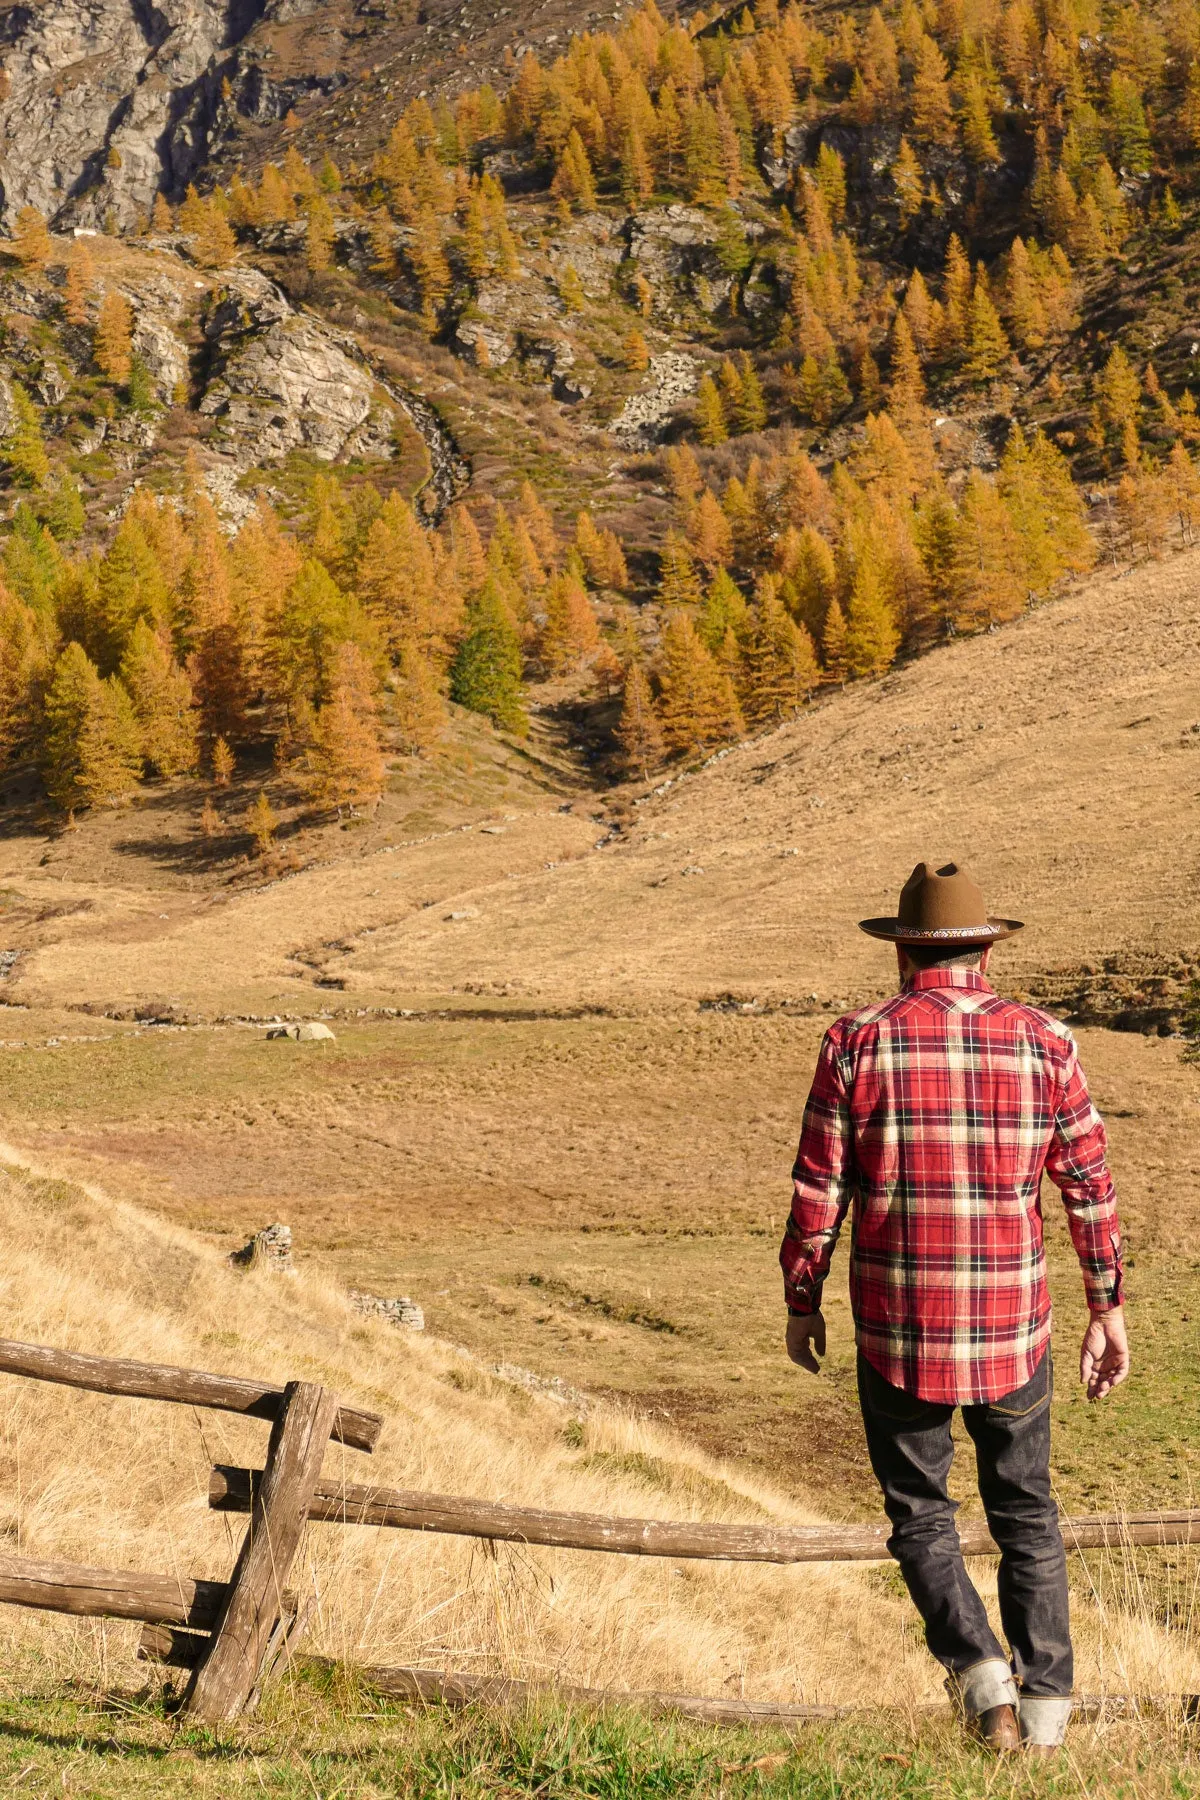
[209,1463,1200,1562]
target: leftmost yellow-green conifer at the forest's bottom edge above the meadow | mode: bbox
[41,644,142,812]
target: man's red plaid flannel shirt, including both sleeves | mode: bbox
[779,968,1123,1406]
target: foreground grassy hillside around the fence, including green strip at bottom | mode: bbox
[0,1163,1200,1800]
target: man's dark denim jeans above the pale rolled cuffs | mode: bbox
[858,1350,1074,1696]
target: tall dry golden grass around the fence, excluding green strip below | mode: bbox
[0,1165,1200,1705]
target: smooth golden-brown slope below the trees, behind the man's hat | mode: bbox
[4,525,1200,1015]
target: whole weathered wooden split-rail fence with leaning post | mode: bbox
[0,1339,1200,1726]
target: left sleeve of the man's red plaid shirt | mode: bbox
[779,1031,853,1312]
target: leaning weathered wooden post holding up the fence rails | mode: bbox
[184,1381,338,1724]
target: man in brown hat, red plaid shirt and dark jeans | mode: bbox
[779,862,1130,1753]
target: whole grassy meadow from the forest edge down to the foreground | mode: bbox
[0,556,1200,1800]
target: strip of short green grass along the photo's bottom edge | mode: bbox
[0,1674,1200,1800]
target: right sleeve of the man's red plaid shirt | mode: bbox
[1045,1044,1124,1312]
